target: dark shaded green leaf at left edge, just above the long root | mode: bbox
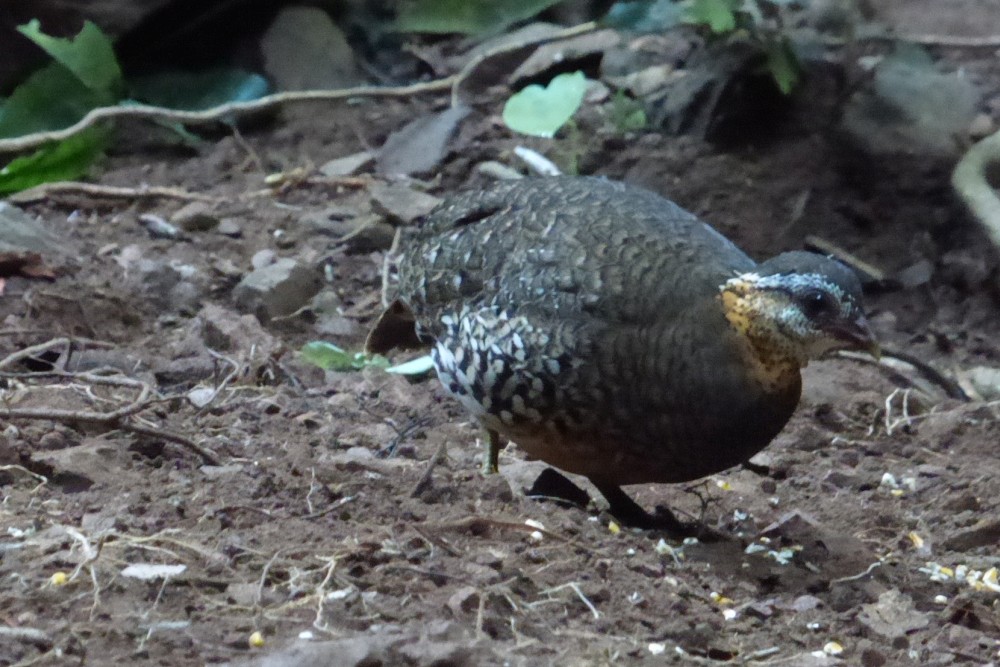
[0,63,115,137]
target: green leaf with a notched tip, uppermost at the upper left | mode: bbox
[17,19,122,93]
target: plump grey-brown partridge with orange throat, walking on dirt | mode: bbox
[367,177,877,530]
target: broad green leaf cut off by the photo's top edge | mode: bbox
[395,0,561,35]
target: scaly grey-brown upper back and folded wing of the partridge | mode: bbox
[397,178,755,326]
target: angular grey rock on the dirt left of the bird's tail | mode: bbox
[233,258,322,322]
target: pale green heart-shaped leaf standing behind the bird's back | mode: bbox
[503,72,587,137]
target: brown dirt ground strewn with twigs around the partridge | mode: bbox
[0,39,1000,666]
